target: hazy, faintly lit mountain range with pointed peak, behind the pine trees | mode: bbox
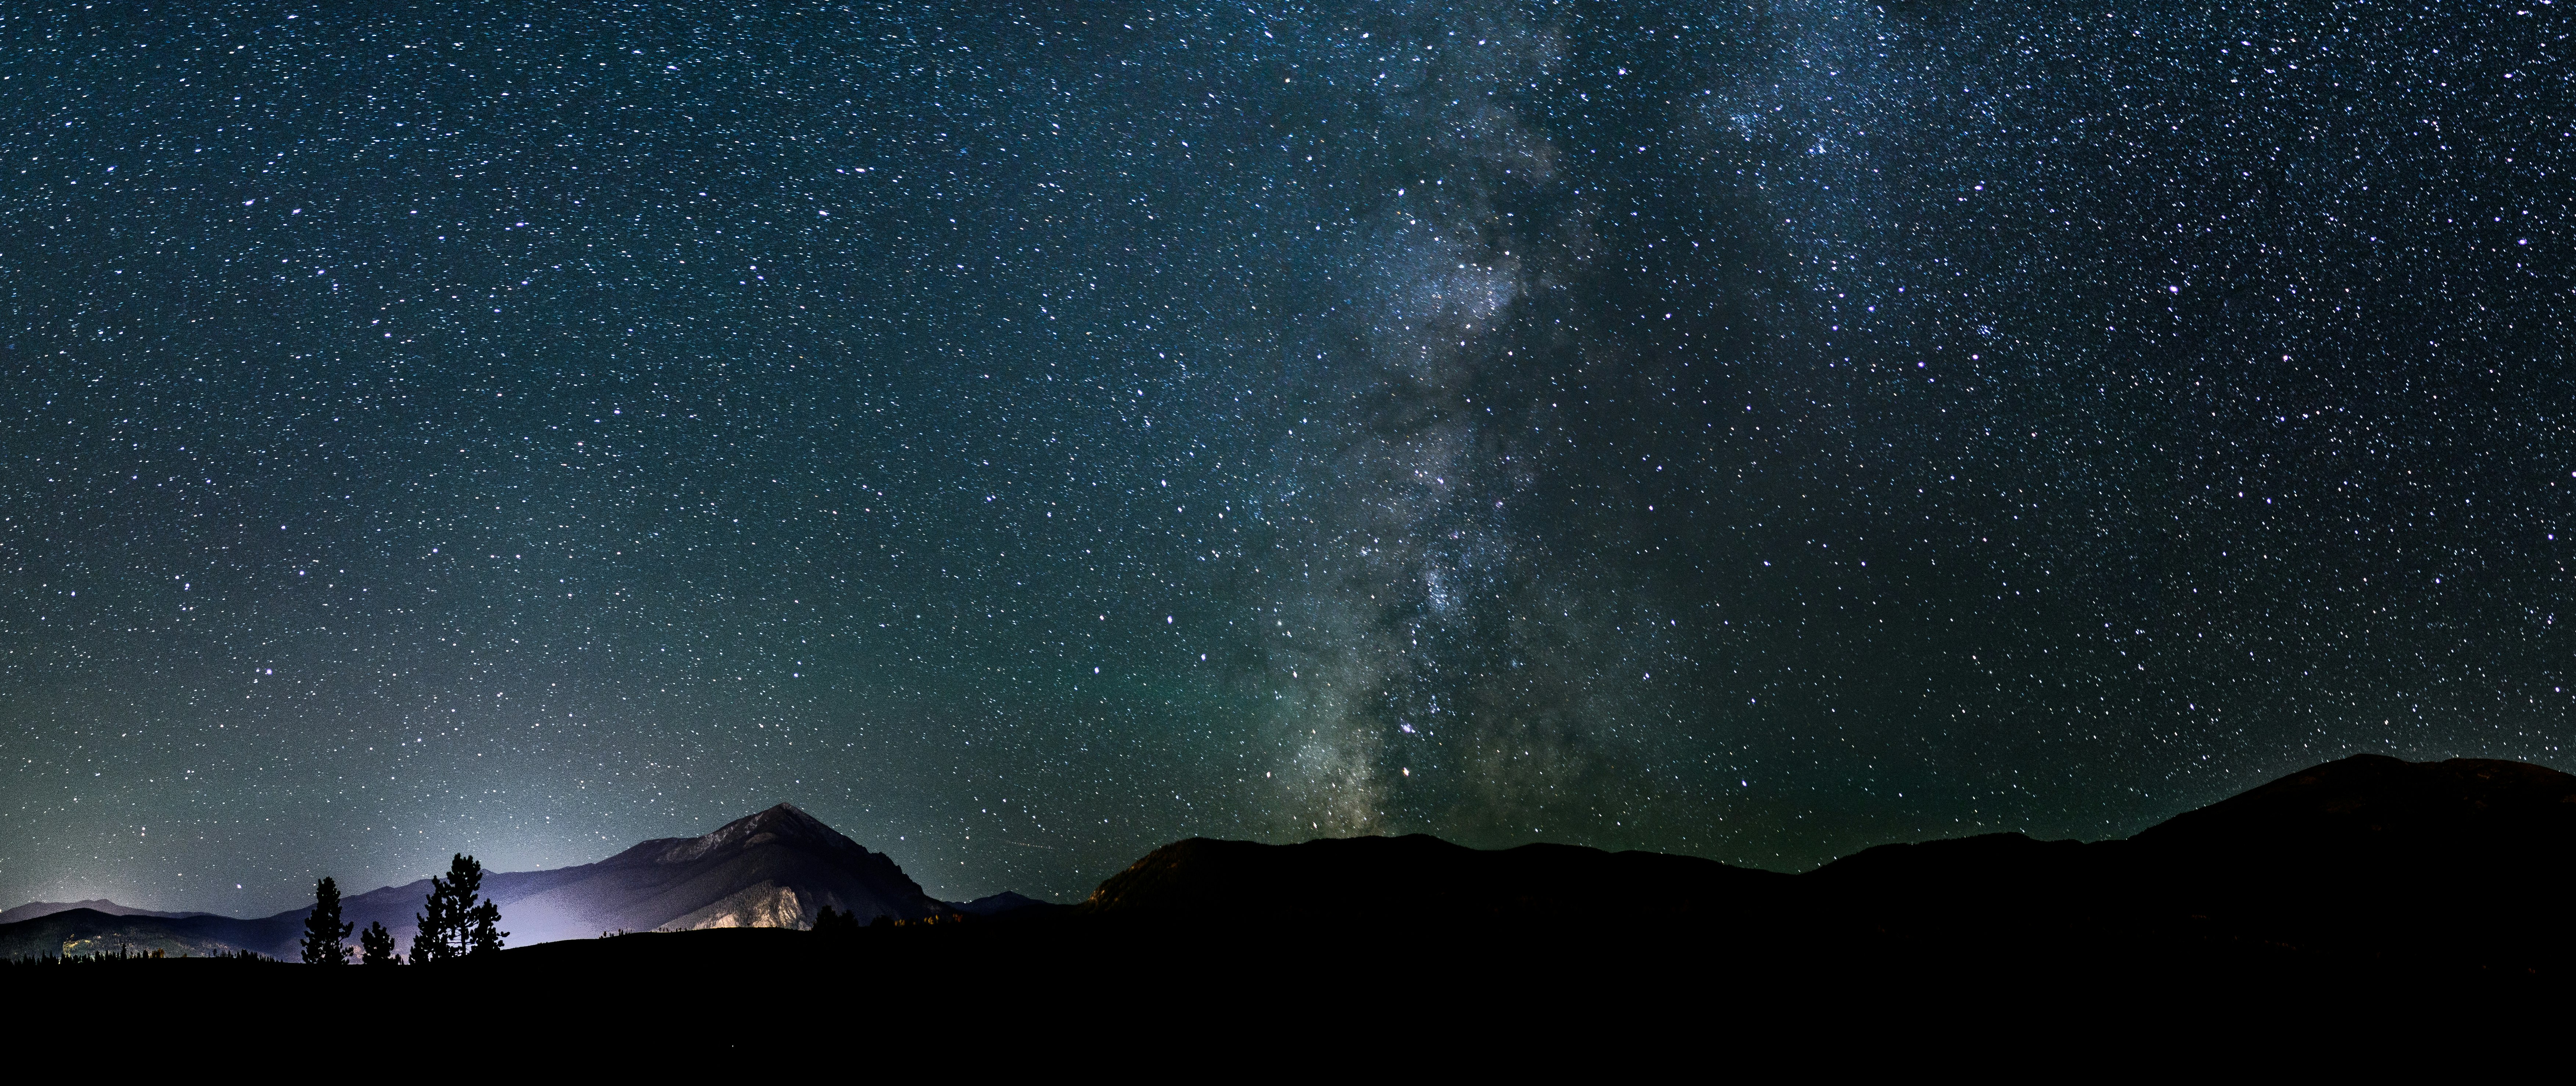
[0,803,992,960]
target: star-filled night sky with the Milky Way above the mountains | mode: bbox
[0,0,2576,914]
